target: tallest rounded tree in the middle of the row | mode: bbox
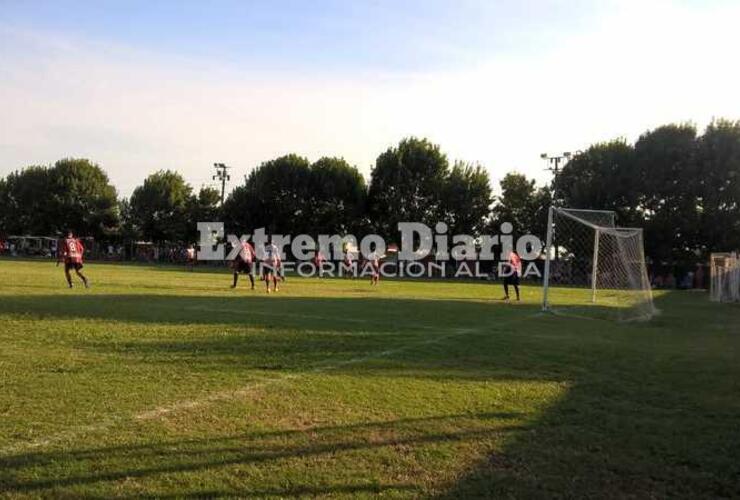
[368,137,449,241]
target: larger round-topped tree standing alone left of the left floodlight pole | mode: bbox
[130,170,193,242]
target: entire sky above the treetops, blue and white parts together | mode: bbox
[0,0,740,196]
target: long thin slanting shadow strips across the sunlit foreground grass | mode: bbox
[0,412,526,496]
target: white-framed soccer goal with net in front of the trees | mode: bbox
[542,207,655,321]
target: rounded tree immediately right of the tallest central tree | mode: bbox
[440,161,493,235]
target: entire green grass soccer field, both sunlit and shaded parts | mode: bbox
[0,260,740,498]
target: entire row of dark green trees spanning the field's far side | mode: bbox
[0,120,740,265]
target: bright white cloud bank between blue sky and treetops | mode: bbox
[0,2,740,194]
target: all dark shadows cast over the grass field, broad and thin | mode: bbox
[0,292,740,498]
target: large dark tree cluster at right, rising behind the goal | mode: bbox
[551,119,740,267]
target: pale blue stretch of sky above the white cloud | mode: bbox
[3,0,594,72]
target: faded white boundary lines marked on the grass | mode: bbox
[0,308,542,455]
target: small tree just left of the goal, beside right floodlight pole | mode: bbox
[491,172,550,240]
